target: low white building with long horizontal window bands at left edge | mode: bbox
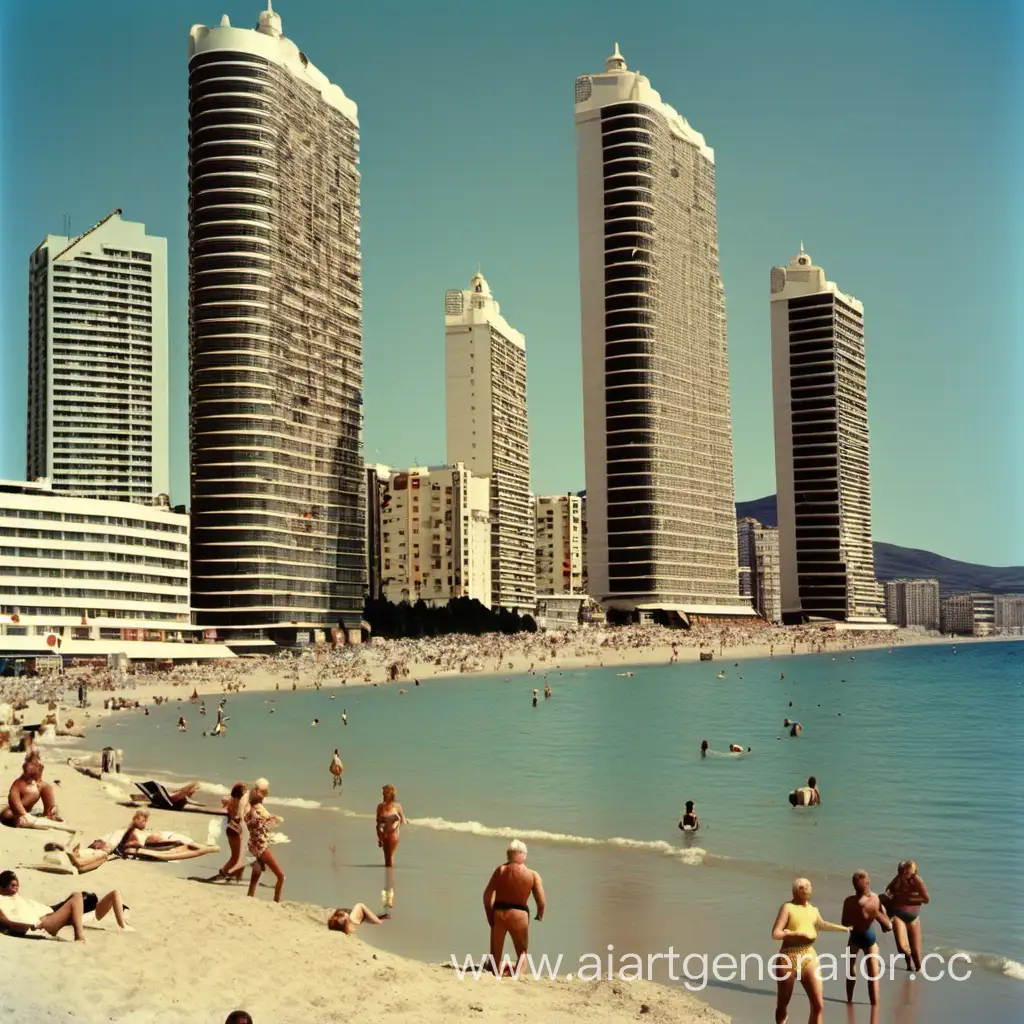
[0,479,231,659]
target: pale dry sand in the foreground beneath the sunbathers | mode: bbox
[0,753,730,1024]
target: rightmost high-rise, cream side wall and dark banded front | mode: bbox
[771,246,884,624]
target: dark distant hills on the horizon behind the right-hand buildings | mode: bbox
[736,495,1024,594]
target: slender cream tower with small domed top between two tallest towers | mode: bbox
[444,273,537,612]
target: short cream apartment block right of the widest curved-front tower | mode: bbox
[376,463,492,605]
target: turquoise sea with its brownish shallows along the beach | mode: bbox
[91,643,1024,1024]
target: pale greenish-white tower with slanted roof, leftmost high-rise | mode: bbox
[27,210,170,504]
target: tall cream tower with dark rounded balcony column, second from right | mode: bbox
[575,44,754,622]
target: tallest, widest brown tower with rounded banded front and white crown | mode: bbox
[188,8,367,646]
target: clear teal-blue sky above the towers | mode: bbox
[0,0,1024,564]
